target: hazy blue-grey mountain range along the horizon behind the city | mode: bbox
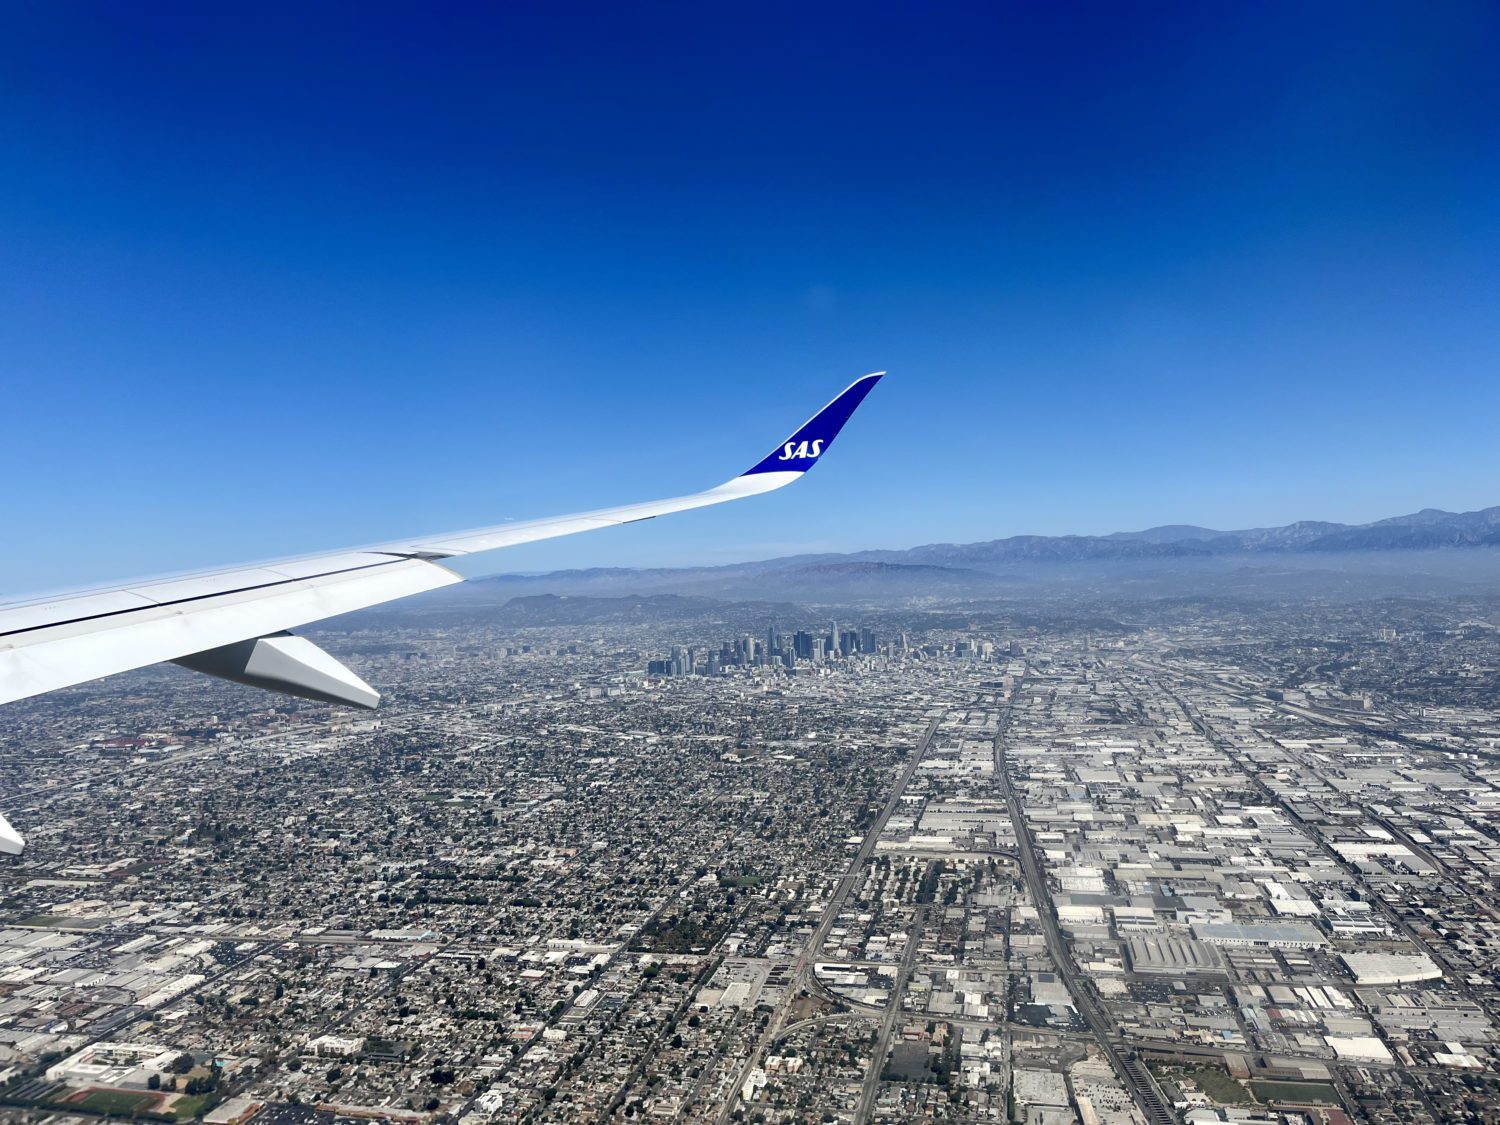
[479,507,1500,611]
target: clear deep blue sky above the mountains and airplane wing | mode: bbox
[0,3,1500,593]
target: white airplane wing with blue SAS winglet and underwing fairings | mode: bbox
[0,372,884,852]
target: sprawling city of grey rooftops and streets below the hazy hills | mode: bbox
[0,602,1500,1125]
